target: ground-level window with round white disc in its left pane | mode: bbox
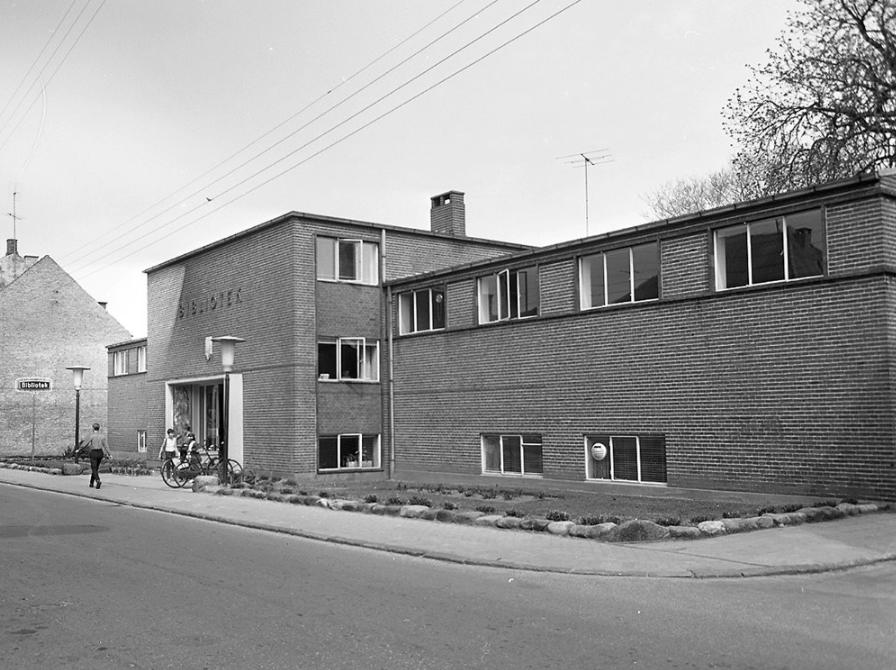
[585,434,666,483]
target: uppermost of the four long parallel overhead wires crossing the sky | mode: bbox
[60,0,472,260]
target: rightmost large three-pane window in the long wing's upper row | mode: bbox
[715,209,824,290]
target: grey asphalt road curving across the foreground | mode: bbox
[0,485,896,670]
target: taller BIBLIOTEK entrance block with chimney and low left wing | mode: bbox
[109,191,528,477]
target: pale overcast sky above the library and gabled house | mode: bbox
[0,0,795,337]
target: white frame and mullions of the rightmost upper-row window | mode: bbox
[712,207,828,292]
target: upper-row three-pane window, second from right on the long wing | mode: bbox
[579,242,659,309]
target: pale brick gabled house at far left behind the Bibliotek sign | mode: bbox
[0,240,130,455]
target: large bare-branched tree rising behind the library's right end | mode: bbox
[723,0,896,194]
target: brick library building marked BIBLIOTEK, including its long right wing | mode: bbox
[110,174,896,499]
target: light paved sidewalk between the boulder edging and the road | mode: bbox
[0,468,896,578]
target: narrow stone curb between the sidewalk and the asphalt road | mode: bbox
[0,482,896,579]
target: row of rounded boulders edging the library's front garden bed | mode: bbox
[193,477,889,542]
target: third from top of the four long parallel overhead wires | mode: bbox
[73,0,541,268]
